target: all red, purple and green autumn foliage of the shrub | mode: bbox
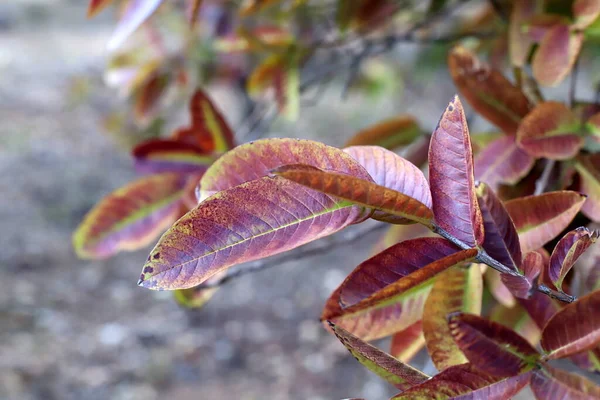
[73,0,600,399]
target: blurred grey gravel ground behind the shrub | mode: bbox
[0,0,472,400]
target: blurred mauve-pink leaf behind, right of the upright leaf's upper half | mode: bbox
[474,136,535,189]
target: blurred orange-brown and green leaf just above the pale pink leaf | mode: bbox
[345,115,422,150]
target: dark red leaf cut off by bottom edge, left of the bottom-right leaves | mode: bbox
[392,364,531,400]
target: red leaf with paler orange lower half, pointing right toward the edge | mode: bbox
[504,190,585,253]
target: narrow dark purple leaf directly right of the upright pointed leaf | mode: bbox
[476,183,522,271]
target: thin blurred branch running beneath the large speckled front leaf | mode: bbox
[194,223,388,291]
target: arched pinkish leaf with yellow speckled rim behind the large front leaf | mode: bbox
[196,139,372,200]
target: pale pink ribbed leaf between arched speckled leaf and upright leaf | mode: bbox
[344,146,431,223]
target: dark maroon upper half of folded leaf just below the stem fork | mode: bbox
[340,237,459,307]
